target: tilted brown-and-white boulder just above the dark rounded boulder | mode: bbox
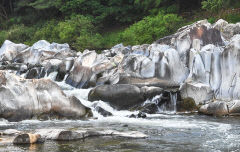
[66,51,123,88]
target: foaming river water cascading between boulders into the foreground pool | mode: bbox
[0,82,240,152]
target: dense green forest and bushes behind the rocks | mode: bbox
[0,0,240,51]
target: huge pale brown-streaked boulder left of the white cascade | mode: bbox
[0,71,90,121]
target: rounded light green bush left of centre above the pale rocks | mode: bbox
[34,15,102,51]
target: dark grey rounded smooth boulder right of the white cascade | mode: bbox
[88,84,144,109]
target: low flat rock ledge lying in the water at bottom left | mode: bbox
[0,129,148,144]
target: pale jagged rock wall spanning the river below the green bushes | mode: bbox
[0,20,240,115]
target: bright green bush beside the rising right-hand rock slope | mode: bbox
[121,14,183,45]
